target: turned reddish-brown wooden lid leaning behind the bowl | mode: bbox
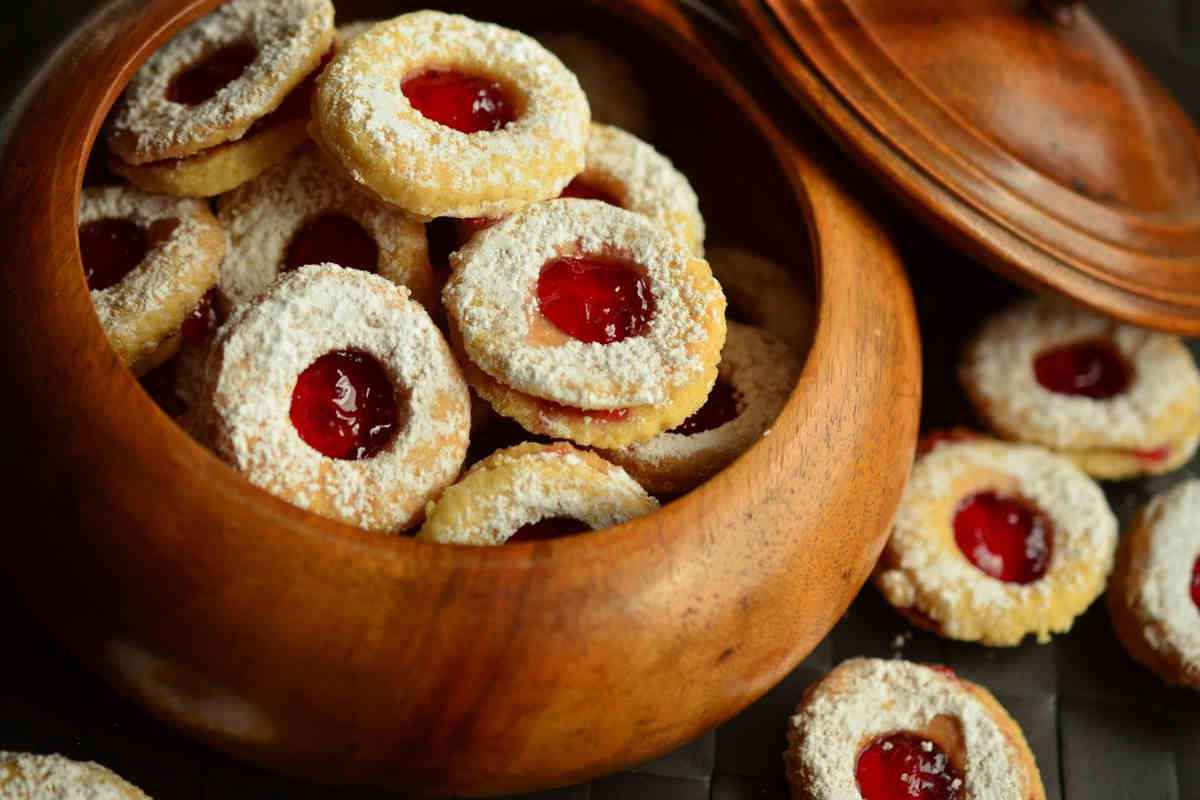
[737,0,1200,333]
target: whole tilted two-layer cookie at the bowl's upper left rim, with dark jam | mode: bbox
[108,0,334,197]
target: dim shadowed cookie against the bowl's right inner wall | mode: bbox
[708,247,814,356]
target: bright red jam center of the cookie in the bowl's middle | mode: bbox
[538,255,654,344]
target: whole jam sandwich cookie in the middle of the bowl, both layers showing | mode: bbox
[443,199,725,447]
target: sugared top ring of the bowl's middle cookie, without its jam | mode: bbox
[442,199,725,409]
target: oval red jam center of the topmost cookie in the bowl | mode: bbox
[401,70,517,133]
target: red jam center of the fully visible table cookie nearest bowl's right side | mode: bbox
[954,492,1052,584]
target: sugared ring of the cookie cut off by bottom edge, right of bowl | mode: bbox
[787,658,1043,800]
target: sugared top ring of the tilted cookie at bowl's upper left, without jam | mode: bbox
[108,0,334,164]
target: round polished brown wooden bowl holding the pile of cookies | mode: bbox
[0,0,920,794]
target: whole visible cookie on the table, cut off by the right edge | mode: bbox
[1108,480,1200,690]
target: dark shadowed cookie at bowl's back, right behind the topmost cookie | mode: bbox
[538,32,654,139]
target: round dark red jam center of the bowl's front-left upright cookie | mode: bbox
[290,350,400,461]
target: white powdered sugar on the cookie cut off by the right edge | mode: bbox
[1127,480,1200,686]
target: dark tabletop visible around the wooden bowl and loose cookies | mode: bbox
[7,0,1200,800]
